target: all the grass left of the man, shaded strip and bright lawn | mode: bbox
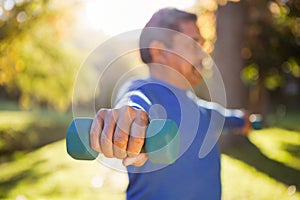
[0,101,127,199]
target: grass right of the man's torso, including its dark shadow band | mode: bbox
[222,128,300,200]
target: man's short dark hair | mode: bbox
[139,8,197,63]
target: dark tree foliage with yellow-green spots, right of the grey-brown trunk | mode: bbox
[242,0,300,111]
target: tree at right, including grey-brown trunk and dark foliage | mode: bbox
[195,0,300,114]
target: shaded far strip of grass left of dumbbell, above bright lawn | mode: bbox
[0,101,72,155]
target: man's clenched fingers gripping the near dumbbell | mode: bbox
[90,106,149,166]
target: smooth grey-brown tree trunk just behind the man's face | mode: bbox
[214,2,246,108]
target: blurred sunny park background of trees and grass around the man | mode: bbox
[0,0,300,200]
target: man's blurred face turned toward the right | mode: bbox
[165,21,205,86]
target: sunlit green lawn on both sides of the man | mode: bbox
[0,102,300,200]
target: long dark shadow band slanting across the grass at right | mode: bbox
[220,134,300,188]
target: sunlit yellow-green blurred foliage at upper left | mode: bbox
[0,0,78,110]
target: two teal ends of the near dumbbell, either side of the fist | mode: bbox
[66,118,180,164]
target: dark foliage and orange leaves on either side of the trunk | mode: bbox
[192,0,300,109]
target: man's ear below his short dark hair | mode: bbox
[149,40,167,64]
